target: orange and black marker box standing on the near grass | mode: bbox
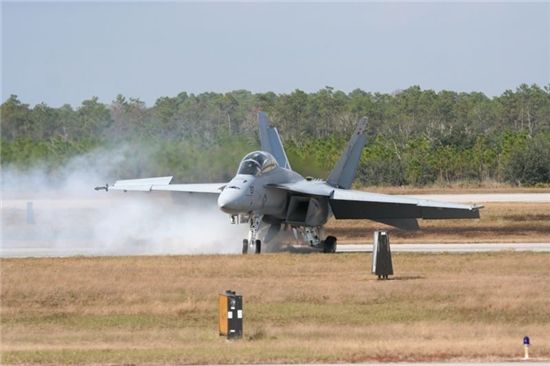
[218,290,243,339]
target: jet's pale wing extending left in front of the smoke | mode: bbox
[100,177,226,194]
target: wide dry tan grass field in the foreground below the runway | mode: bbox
[0,252,550,365]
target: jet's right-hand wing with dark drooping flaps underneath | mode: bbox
[267,181,483,219]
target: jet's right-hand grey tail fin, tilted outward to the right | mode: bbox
[327,117,368,189]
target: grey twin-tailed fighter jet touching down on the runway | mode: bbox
[96,112,482,254]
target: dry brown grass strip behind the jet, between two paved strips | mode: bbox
[326,202,550,243]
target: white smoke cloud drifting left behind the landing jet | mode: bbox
[1,148,247,256]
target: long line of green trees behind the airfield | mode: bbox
[0,84,550,186]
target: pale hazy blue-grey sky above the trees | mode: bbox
[2,1,550,106]
